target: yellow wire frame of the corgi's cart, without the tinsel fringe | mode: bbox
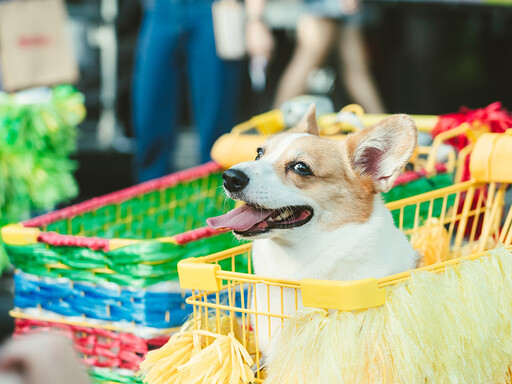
[179,132,512,382]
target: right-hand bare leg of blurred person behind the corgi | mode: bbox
[338,22,385,113]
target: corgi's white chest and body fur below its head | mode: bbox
[253,195,418,352]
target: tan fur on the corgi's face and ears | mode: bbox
[255,113,416,231]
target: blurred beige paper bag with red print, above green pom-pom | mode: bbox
[0,0,78,91]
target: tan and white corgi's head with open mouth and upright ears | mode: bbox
[208,106,417,239]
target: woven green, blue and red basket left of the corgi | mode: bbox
[2,162,242,383]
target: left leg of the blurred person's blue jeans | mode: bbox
[133,0,184,182]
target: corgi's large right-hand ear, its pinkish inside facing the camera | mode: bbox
[346,115,418,192]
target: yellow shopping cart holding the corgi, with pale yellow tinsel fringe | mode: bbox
[141,133,512,383]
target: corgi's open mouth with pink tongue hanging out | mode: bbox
[206,204,313,237]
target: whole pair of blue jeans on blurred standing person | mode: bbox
[133,0,242,182]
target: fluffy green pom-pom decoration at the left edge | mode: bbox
[0,85,85,270]
